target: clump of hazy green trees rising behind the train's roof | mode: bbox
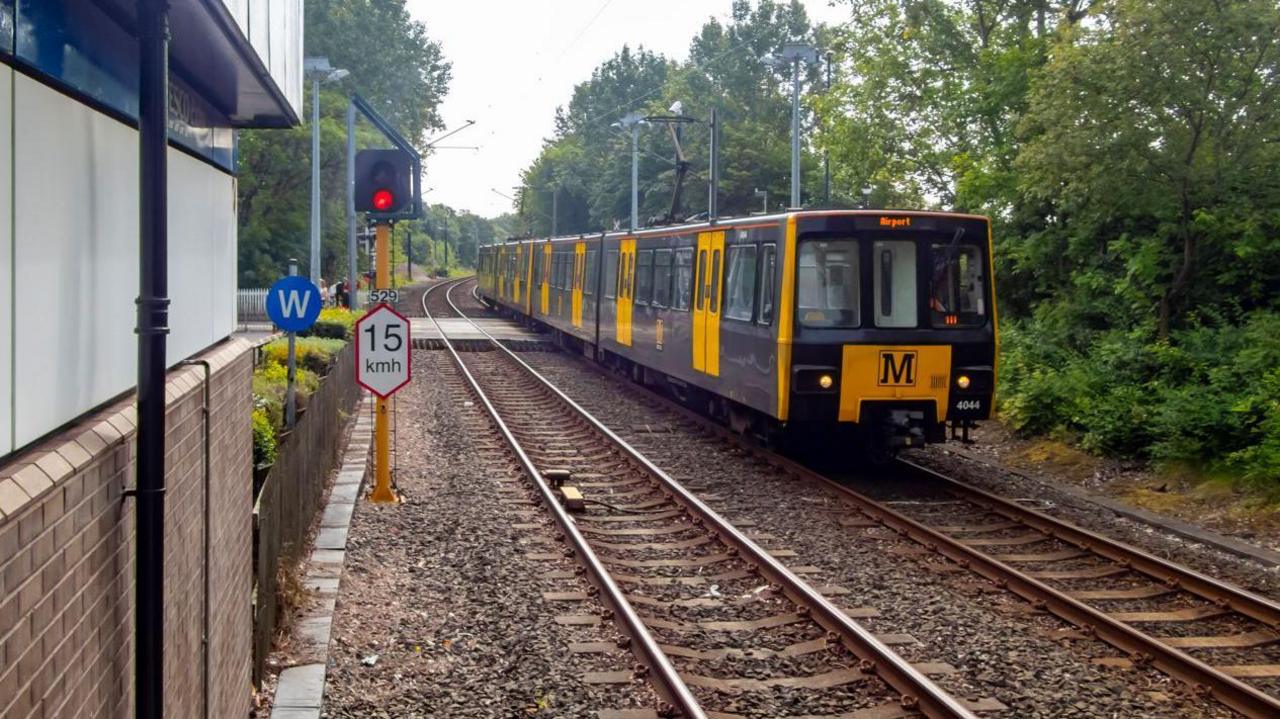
[512,0,820,235]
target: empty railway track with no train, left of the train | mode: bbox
[422,281,974,716]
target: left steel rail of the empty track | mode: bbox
[422,278,707,719]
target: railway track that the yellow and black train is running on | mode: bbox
[519,335,1280,718]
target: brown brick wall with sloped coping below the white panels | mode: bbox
[0,340,253,719]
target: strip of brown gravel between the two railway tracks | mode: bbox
[524,353,1234,718]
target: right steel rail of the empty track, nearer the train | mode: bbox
[445,278,974,719]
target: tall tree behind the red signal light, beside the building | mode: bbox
[237,0,449,287]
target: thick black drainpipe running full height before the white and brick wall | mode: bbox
[133,0,169,719]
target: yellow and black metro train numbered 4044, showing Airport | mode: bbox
[477,210,998,458]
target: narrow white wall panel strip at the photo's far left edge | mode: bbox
[0,71,14,454]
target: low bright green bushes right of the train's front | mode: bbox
[1000,312,1280,481]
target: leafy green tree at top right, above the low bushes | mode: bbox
[1018,0,1280,338]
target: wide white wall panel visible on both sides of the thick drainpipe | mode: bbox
[11,74,236,446]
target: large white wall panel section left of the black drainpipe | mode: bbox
[14,74,138,445]
